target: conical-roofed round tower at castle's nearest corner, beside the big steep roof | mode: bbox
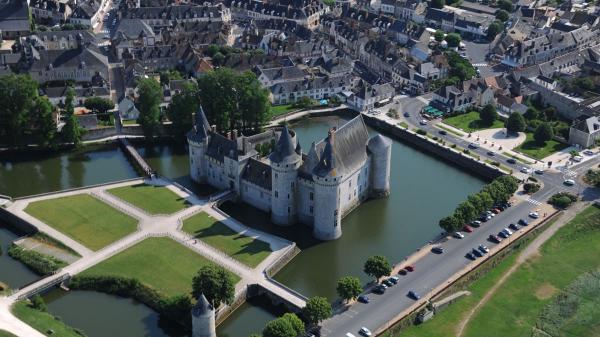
[313,130,342,240]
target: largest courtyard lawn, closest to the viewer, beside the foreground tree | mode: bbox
[82,237,240,296]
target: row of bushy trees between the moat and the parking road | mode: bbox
[439,175,519,232]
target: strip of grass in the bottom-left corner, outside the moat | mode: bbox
[11,301,81,337]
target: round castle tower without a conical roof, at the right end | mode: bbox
[367,135,392,198]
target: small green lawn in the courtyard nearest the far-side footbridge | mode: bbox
[107,184,189,214]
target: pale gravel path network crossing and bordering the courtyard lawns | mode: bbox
[0,178,306,336]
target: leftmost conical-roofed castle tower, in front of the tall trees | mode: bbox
[187,106,210,183]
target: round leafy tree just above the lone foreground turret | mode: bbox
[192,265,235,308]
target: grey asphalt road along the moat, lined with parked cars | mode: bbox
[321,108,600,337]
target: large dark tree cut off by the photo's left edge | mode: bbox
[0,74,38,145]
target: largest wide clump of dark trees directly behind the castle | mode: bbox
[198,68,271,133]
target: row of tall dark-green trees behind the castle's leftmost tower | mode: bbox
[137,68,271,138]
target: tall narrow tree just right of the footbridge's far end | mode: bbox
[137,78,163,140]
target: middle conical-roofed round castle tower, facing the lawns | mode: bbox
[269,126,302,226]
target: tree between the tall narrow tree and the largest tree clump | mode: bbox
[167,82,199,139]
